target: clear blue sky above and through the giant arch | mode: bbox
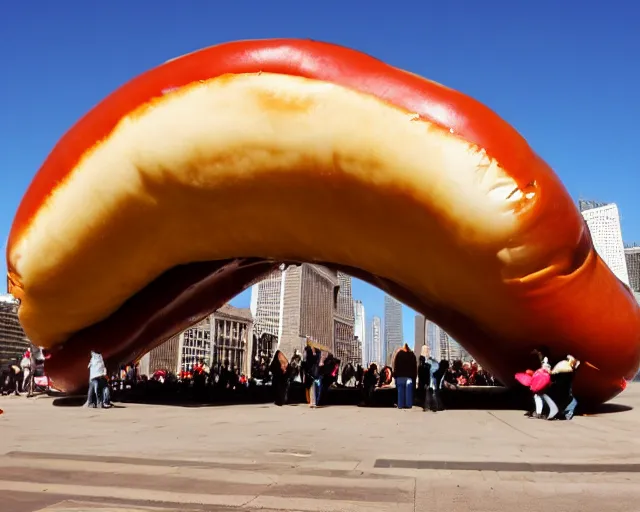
[0,0,640,341]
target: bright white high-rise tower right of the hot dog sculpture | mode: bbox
[579,201,629,286]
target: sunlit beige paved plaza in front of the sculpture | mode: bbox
[0,384,640,512]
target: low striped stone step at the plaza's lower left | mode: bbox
[0,452,415,512]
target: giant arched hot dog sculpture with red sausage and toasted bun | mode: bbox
[7,40,640,402]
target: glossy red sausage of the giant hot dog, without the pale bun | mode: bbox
[8,40,640,402]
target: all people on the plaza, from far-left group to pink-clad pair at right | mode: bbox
[5,344,580,420]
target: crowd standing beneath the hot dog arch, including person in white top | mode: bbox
[74,345,500,411]
